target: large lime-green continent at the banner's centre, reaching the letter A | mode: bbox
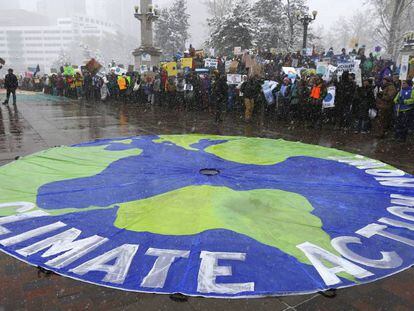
[115,186,336,263]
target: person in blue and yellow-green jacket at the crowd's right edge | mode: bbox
[394,80,414,142]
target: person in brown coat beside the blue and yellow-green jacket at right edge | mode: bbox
[375,76,398,138]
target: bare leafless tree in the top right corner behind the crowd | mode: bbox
[369,0,414,57]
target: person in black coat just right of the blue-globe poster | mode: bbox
[353,79,375,133]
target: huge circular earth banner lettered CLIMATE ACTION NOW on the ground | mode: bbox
[0,135,414,298]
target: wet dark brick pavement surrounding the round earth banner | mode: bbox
[0,91,414,311]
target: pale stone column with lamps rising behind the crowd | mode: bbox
[132,0,161,70]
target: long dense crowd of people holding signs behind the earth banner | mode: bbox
[3,47,414,141]
